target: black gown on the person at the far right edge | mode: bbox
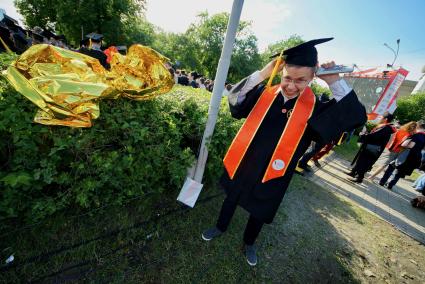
[397,133,425,177]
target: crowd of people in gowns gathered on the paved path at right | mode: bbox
[298,113,425,195]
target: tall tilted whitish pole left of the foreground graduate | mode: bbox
[193,0,244,183]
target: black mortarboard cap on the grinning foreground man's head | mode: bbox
[270,37,333,67]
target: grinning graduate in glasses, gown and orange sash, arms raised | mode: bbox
[202,39,367,265]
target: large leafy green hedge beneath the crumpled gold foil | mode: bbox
[0,71,240,222]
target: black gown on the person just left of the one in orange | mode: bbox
[353,124,394,175]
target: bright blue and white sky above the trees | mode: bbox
[0,0,425,80]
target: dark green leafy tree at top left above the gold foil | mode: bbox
[15,0,146,45]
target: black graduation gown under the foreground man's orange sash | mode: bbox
[220,85,367,223]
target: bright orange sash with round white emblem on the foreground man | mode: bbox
[223,85,316,183]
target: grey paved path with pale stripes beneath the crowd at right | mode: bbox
[306,153,425,244]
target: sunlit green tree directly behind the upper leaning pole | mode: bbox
[154,13,261,82]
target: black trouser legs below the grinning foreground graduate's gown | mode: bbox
[216,198,264,246]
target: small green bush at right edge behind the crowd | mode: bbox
[394,93,425,124]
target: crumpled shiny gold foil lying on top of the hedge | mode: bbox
[3,44,174,127]
